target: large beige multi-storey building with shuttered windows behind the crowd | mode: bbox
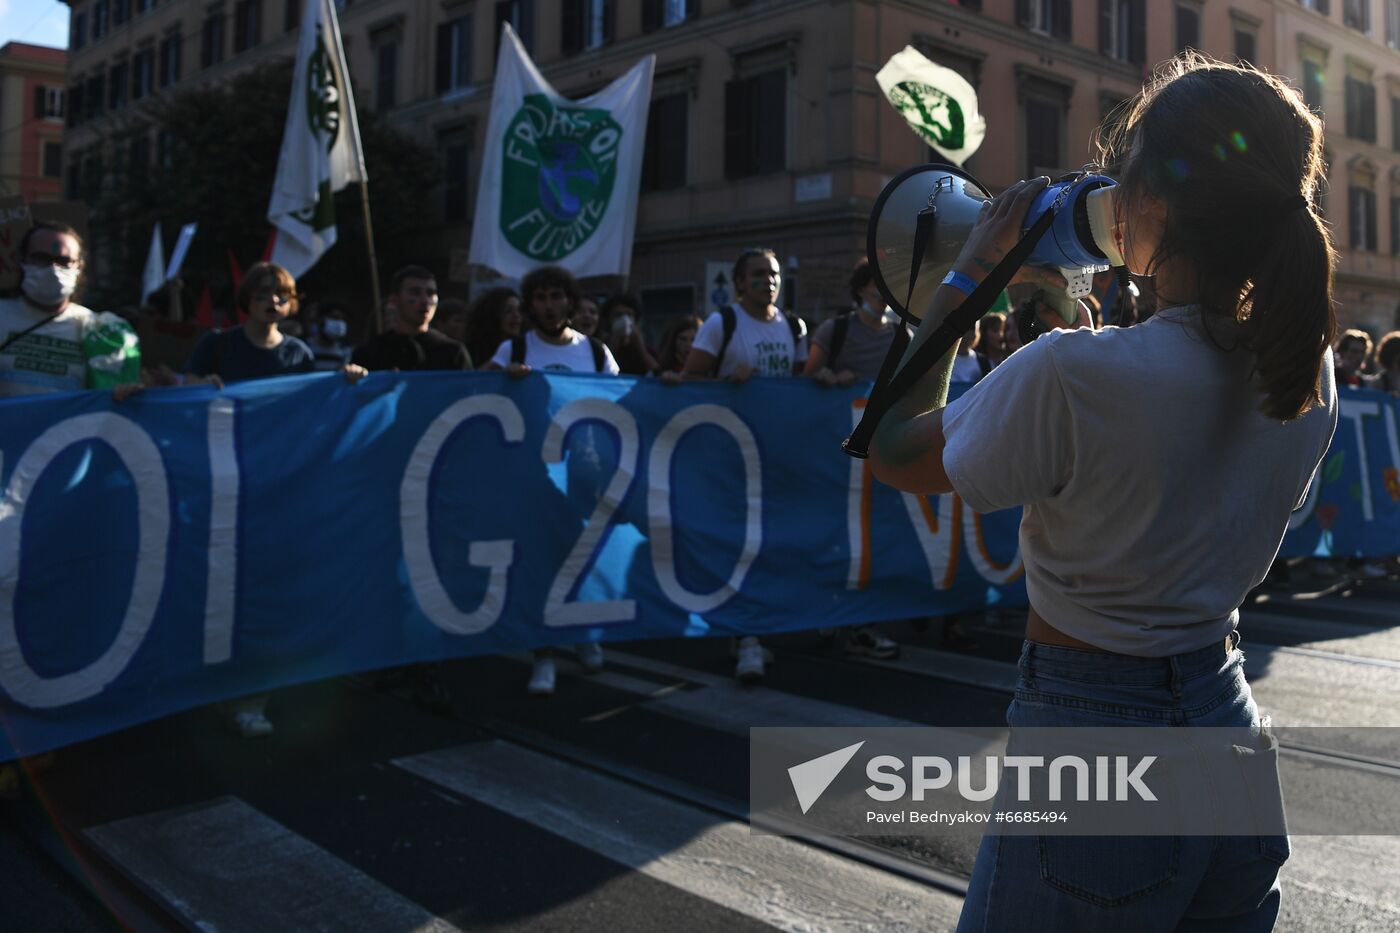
[67,0,1400,332]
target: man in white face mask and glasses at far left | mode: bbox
[0,220,141,398]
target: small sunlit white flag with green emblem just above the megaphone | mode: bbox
[875,45,987,165]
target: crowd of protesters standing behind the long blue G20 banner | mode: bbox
[0,215,1400,717]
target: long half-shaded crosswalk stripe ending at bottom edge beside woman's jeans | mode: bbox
[393,741,962,932]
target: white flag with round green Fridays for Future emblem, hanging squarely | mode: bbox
[470,22,657,277]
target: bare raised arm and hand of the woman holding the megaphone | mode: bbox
[869,177,1049,495]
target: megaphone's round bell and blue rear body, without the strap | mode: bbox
[865,163,1123,326]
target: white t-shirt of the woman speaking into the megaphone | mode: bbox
[944,307,1337,657]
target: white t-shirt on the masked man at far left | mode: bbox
[0,298,97,396]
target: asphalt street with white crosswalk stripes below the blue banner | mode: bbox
[0,571,1400,933]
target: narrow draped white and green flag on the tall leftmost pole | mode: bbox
[267,0,367,277]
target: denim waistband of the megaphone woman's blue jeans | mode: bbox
[1019,630,1243,686]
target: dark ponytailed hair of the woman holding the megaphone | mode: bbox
[1099,52,1337,420]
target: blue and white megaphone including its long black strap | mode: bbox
[841,163,1127,457]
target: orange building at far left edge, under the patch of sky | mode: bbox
[0,42,67,203]
